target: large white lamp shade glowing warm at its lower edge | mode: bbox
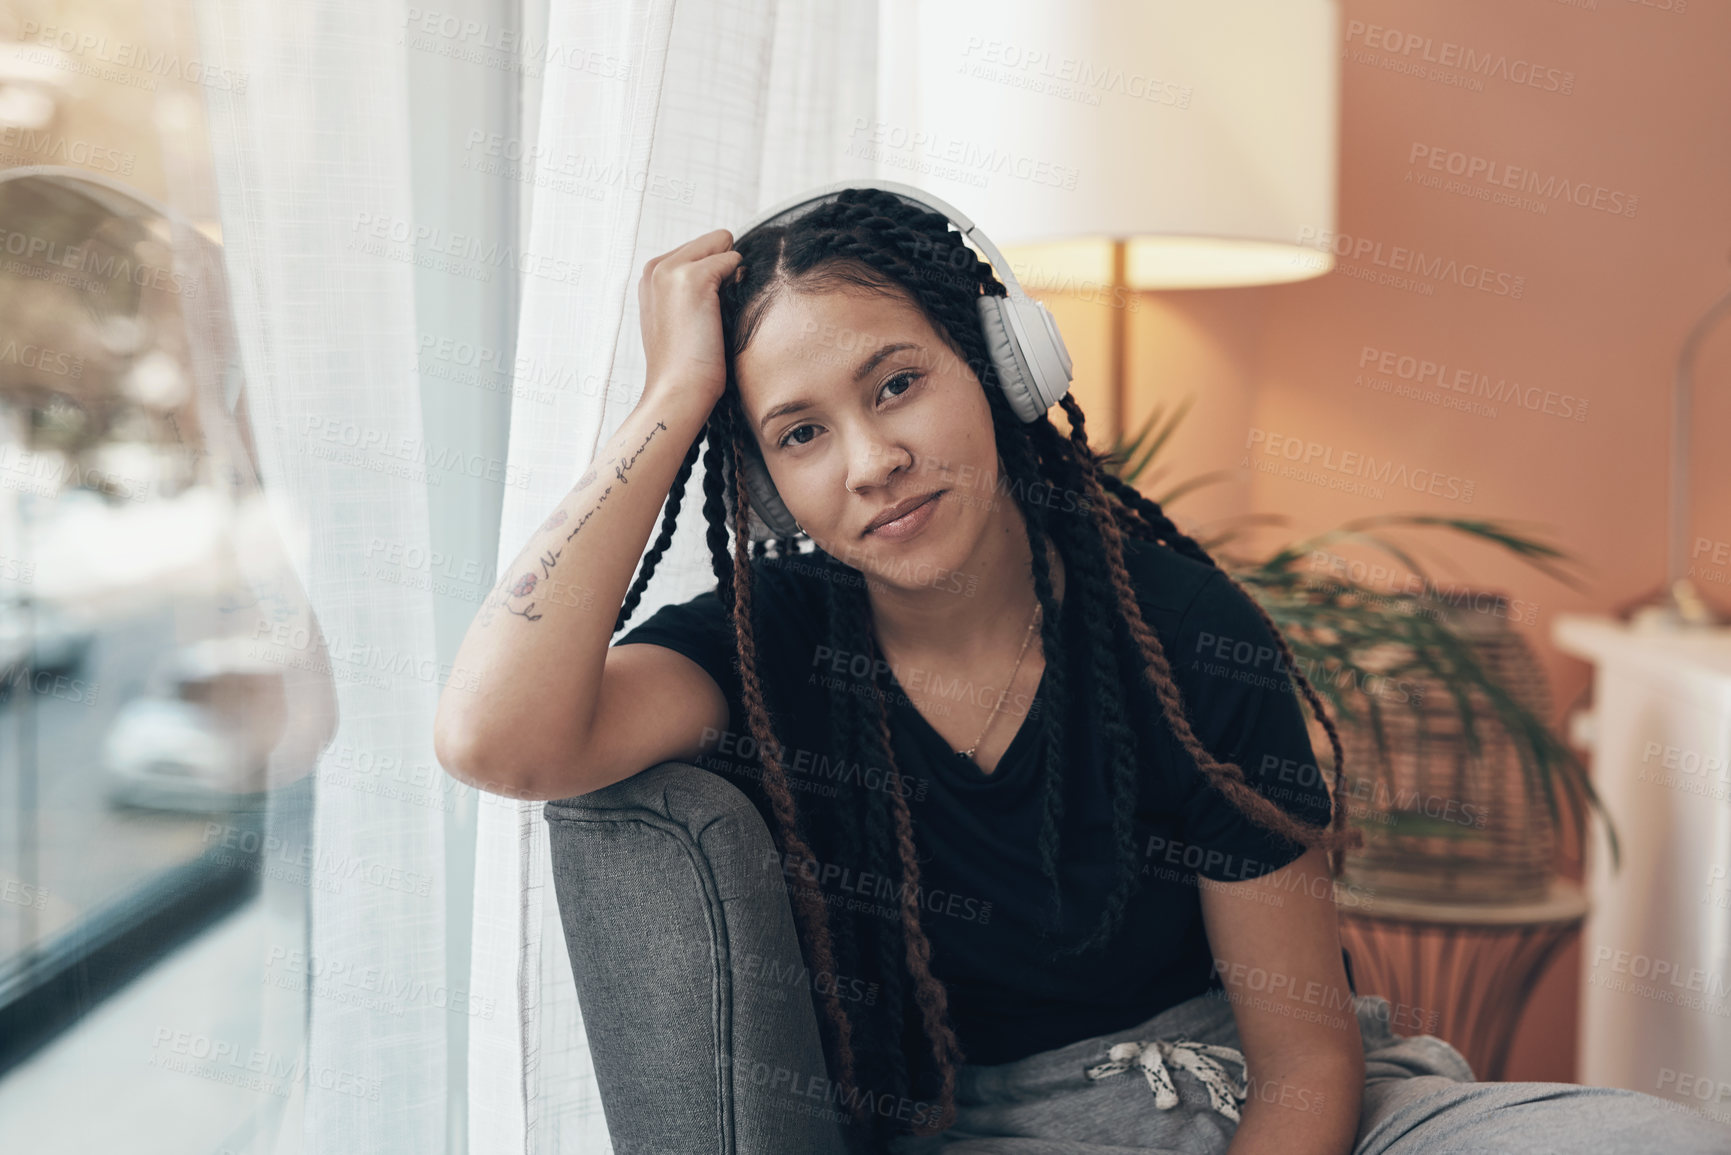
[879,0,1340,289]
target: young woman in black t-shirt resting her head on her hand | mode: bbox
[438,189,1731,1155]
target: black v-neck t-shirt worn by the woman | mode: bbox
[616,539,1331,1063]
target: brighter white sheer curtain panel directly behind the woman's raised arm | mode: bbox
[469,0,878,1155]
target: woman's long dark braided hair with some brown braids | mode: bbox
[615,189,1362,1150]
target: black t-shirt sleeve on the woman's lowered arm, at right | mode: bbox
[1168,571,1333,881]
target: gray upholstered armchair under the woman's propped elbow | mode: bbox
[545,762,846,1155]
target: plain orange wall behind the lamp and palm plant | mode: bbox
[1052,0,1731,1081]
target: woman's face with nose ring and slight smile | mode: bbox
[734,287,1013,589]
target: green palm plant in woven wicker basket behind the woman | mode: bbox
[1101,398,1618,902]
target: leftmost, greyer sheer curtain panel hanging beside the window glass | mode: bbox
[199,0,464,1155]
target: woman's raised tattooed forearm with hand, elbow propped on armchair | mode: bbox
[433,229,741,798]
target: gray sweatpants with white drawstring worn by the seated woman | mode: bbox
[890,996,1731,1155]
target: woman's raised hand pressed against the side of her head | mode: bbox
[637,229,743,410]
